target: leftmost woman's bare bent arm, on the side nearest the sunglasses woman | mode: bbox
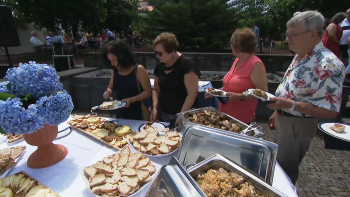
[133,65,152,102]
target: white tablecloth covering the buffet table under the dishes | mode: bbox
[0,120,297,197]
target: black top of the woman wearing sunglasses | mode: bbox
[154,55,201,115]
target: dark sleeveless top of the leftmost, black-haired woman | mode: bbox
[113,66,143,120]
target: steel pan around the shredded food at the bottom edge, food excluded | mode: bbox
[187,154,286,197]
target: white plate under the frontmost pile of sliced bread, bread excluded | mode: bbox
[80,147,162,197]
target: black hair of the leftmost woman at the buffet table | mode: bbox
[102,41,136,68]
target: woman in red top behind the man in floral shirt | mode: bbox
[322,12,346,57]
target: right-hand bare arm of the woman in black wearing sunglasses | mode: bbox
[181,72,198,112]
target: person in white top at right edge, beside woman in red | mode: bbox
[339,8,350,64]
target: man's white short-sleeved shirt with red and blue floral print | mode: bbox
[276,42,345,116]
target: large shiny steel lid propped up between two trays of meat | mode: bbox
[177,125,278,185]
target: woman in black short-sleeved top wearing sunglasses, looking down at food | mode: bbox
[151,33,200,126]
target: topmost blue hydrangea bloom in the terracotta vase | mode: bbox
[5,62,63,99]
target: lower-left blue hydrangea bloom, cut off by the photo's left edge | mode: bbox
[0,98,44,135]
